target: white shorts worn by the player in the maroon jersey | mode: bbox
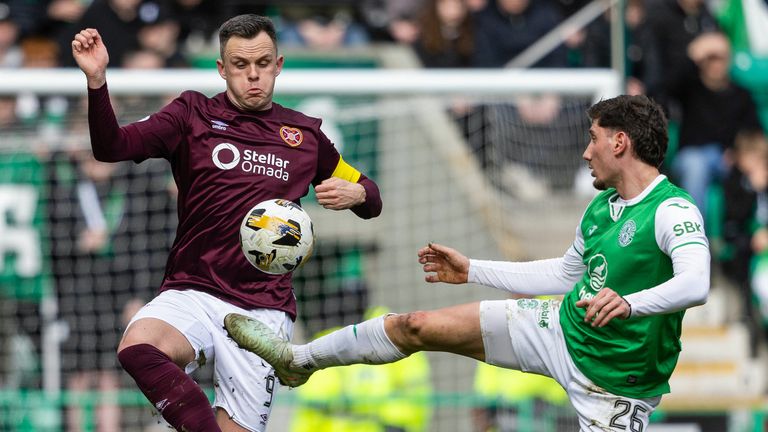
[128,290,293,432]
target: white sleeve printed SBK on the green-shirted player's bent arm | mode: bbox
[624,198,711,317]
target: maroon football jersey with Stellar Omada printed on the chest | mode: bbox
[88,85,381,318]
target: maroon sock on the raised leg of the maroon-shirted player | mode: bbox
[117,344,221,432]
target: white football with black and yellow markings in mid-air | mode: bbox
[240,199,315,274]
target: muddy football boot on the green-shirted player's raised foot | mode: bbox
[224,313,316,387]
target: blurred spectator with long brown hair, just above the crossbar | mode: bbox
[414,0,474,68]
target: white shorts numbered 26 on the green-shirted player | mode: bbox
[480,299,661,432]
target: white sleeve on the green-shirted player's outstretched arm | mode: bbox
[468,215,586,295]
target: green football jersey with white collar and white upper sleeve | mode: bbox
[560,176,708,398]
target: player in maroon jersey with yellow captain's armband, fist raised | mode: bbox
[72,15,381,432]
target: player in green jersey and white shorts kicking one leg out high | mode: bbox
[225,96,710,432]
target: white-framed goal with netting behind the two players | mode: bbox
[0,69,618,431]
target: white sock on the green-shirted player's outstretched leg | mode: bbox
[292,315,407,369]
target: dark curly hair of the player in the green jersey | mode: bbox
[587,95,668,168]
